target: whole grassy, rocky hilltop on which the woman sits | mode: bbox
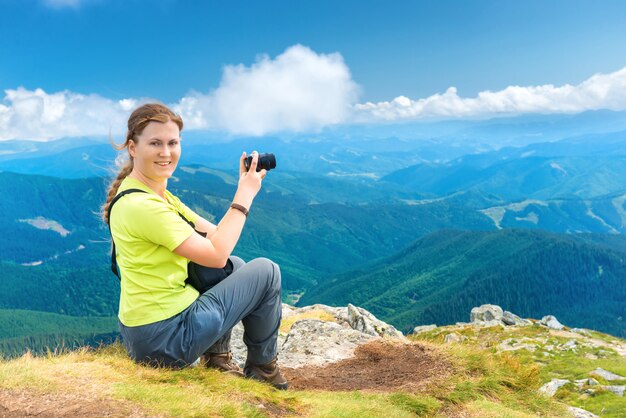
[0,305,626,417]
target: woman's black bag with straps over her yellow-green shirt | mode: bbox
[107,189,233,293]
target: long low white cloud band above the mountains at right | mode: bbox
[355,67,626,121]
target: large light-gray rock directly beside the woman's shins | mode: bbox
[279,319,380,368]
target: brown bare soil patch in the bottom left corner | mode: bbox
[0,388,154,418]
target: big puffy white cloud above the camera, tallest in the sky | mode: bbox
[176,45,359,135]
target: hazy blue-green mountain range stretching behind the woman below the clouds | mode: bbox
[0,112,626,353]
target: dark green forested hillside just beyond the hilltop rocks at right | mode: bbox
[299,230,626,336]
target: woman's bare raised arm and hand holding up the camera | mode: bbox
[174,151,267,268]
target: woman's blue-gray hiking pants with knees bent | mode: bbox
[118,256,282,367]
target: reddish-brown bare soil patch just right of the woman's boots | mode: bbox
[283,340,452,391]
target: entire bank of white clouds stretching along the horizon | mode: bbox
[0,45,626,140]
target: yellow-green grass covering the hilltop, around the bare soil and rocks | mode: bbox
[0,324,626,418]
